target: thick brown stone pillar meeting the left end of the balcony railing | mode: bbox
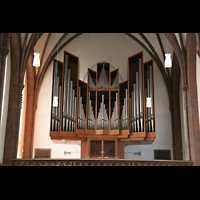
[3,33,24,165]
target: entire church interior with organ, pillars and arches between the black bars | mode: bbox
[0,33,200,166]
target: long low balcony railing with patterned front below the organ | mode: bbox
[13,159,194,166]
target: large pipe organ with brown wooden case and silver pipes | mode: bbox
[50,51,156,159]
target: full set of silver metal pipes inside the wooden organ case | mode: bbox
[51,55,155,138]
